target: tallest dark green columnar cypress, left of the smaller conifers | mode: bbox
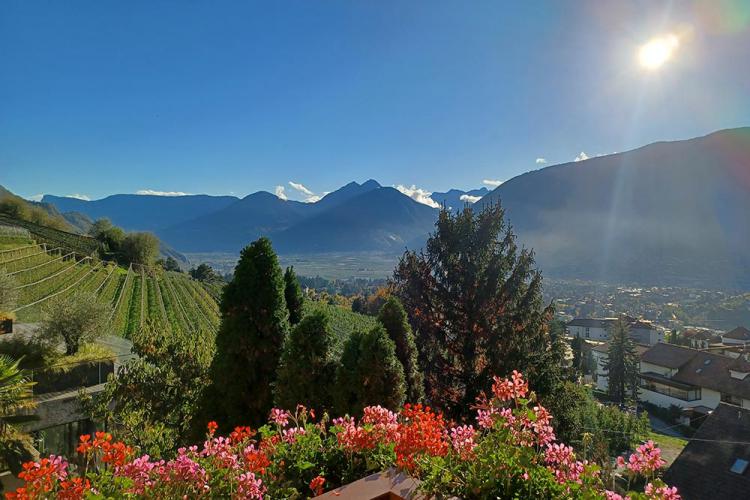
[211,238,289,426]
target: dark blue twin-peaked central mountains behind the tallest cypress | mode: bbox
[157,180,437,253]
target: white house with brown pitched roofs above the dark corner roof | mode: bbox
[639,343,750,409]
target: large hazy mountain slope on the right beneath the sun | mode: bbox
[478,128,750,289]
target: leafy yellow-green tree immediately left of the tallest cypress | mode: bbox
[82,322,214,457]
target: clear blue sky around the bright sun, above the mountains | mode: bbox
[0,0,750,200]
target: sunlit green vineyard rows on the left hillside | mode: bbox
[0,239,219,337]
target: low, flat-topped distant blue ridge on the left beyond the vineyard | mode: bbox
[42,194,238,231]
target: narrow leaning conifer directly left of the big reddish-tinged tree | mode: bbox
[378,297,424,403]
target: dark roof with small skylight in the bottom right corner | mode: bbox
[664,403,750,500]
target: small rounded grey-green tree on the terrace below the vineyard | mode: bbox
[39,292,112,355]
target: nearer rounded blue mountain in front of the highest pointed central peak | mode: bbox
[271,187,438,253]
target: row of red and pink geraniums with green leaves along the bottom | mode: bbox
[9,372,679,500]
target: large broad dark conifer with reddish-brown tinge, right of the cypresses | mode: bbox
[393,205,565,418]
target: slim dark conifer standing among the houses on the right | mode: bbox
[604,318,639,403]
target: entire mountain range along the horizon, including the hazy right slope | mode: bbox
[42,128,750,289]
